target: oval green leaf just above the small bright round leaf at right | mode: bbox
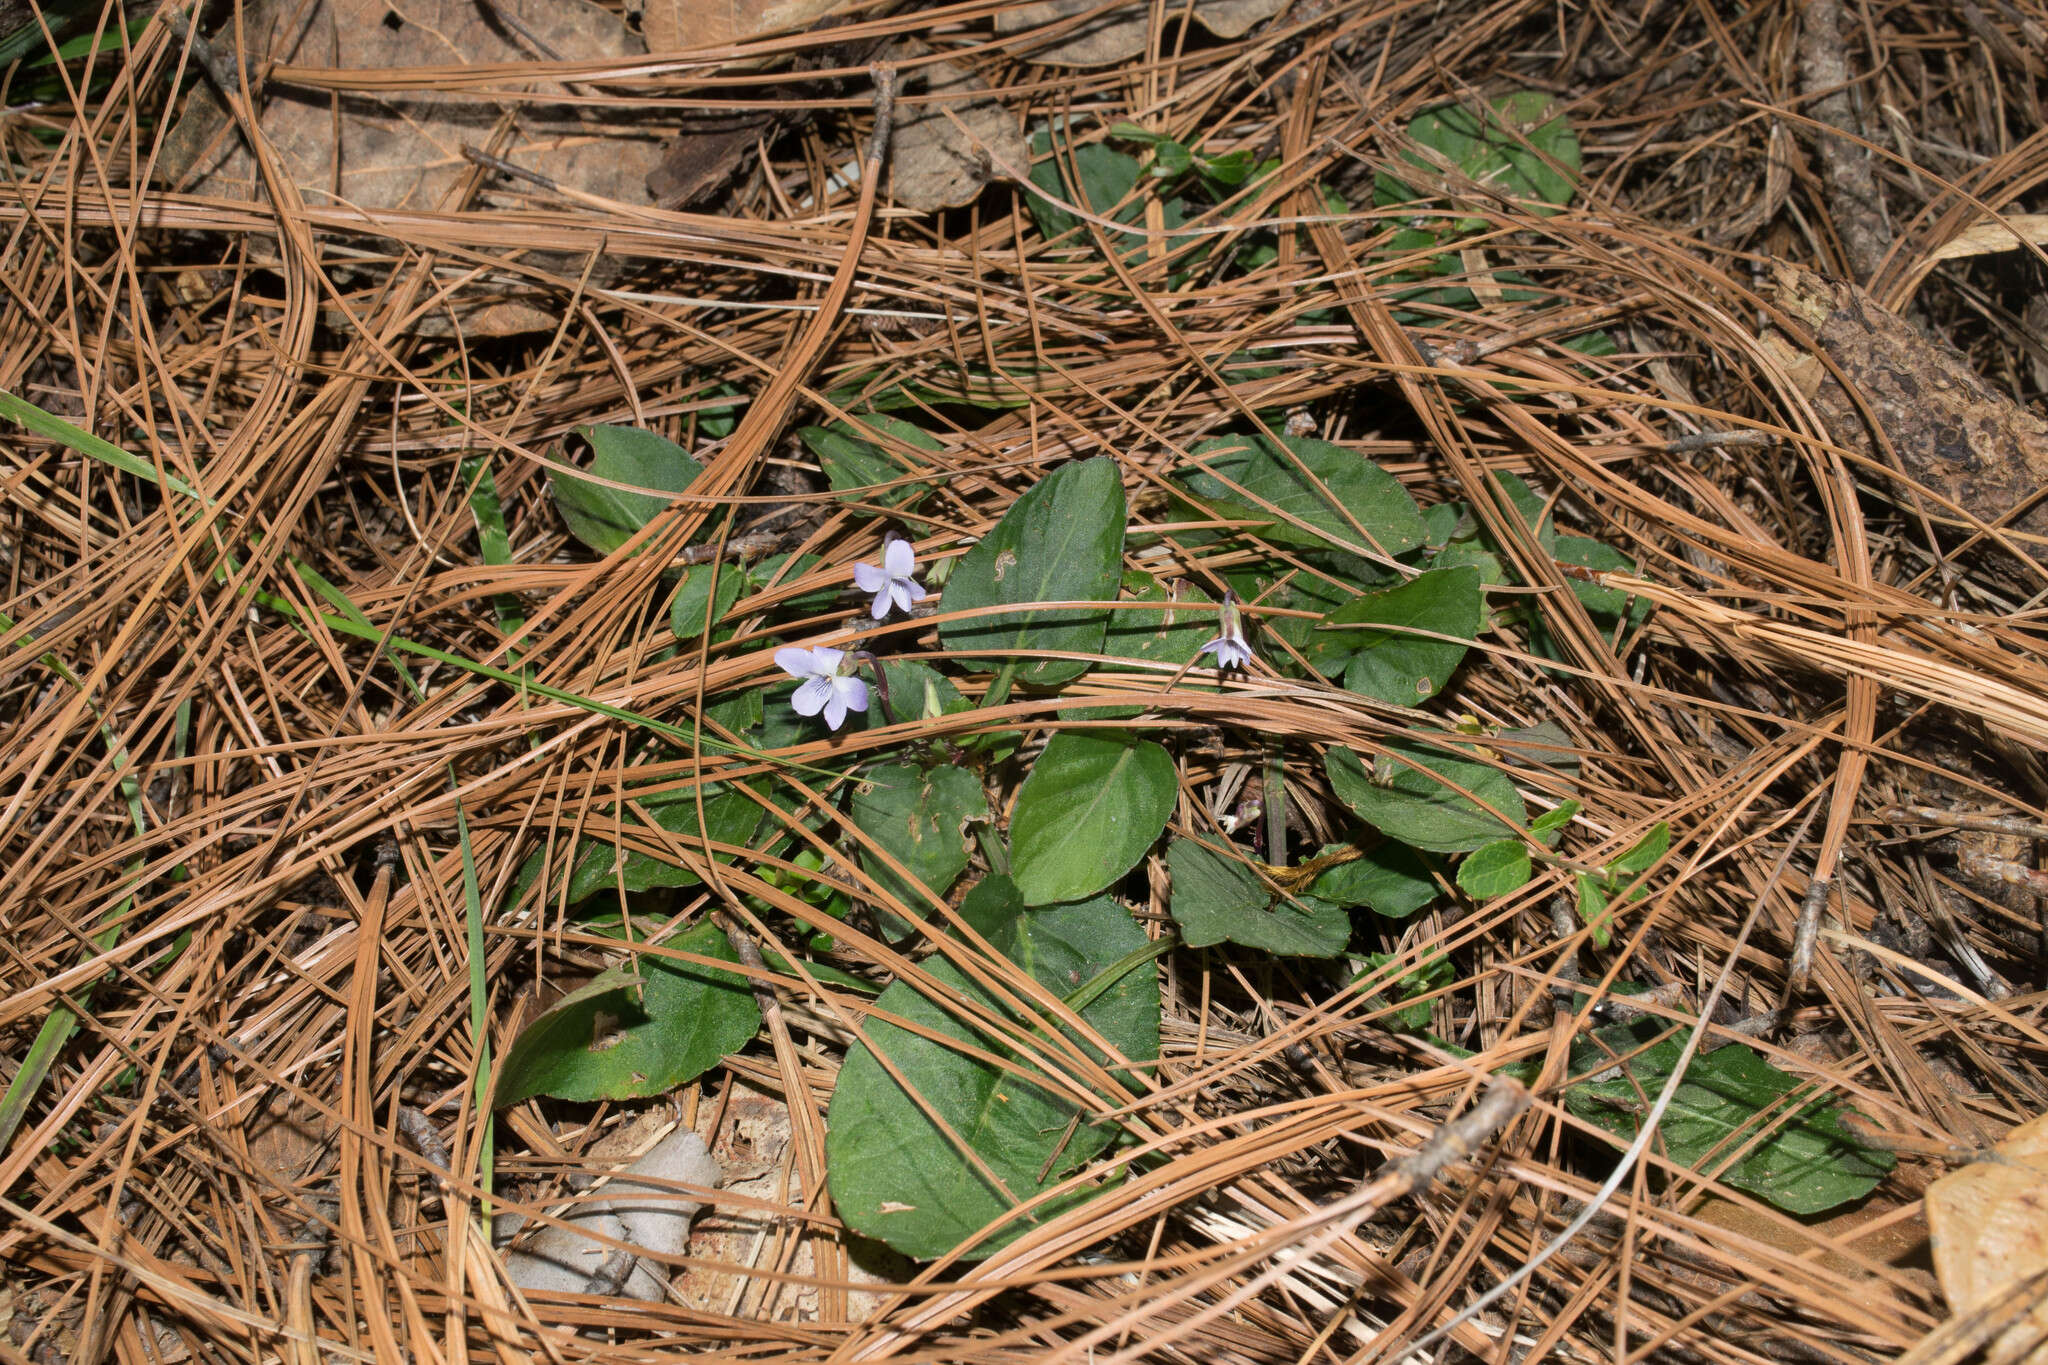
[1323,741,1528,853]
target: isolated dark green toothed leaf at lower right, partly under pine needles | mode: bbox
[1565,1019,1894,1216]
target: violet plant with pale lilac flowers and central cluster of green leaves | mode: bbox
[528,417,1875,1257]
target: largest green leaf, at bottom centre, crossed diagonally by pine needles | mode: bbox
[825,878,1159,1259]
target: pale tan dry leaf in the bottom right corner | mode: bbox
[1927,1113,2048,1365]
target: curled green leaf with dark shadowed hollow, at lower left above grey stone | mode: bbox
[492,923,762,1109]
